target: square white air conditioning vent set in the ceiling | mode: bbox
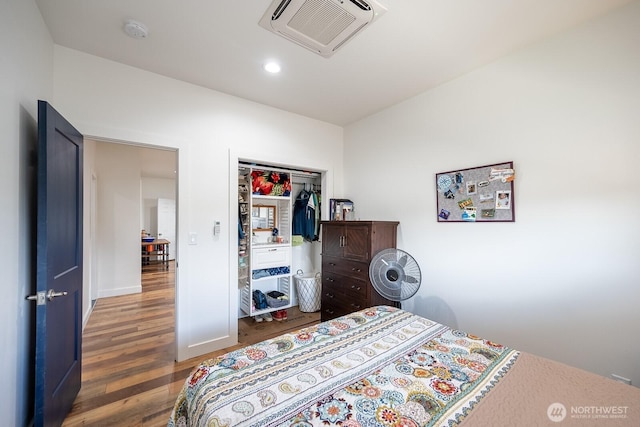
[260,0,387,57]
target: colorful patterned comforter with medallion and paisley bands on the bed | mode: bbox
[169,307,519,427]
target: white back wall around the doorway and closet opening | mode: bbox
[54,46,343,360]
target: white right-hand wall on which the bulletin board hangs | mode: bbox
[344,2,640,385]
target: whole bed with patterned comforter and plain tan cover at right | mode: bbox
[169,306,640,427]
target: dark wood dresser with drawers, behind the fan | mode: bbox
[321,221,399,322]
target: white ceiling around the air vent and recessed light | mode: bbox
[36,0,630,125]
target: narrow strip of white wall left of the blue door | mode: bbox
[0,0,53,426]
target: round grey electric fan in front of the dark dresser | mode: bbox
[369,248,422,302]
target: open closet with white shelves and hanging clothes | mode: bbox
[238,162,322,317]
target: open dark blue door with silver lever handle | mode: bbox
[34,101,83,427]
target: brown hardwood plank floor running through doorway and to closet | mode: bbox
[63,262,320,426]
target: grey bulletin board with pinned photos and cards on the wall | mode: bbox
[436,162,516,222]
